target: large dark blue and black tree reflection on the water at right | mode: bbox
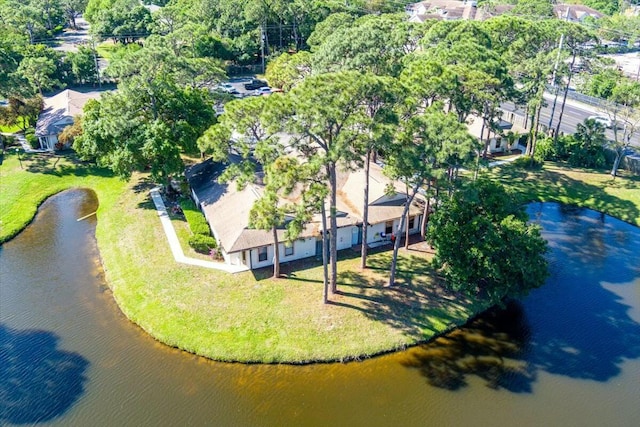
[404,203,640,392]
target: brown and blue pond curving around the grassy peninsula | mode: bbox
[0,190,640,426]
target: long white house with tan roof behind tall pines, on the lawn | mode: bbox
[186,160,422,269]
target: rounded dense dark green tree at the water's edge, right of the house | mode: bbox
[428,179,548,302]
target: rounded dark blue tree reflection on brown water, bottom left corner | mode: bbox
[0,325,89,424]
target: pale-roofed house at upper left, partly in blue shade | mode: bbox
[35,89,102,151]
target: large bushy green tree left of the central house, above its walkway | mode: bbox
[74,55,215,182]
